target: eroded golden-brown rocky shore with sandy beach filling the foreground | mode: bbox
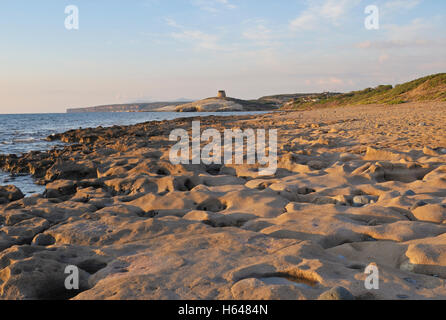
[0,102,446,300]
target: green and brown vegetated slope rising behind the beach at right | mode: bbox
[284,73,446,109]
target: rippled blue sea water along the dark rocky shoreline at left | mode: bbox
[0,112,264,195]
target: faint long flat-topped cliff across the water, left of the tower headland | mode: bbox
[67,101,190,113]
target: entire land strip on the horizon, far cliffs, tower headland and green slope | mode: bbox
[67,73,446,113]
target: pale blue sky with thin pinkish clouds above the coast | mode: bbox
[0,0,446,113]
